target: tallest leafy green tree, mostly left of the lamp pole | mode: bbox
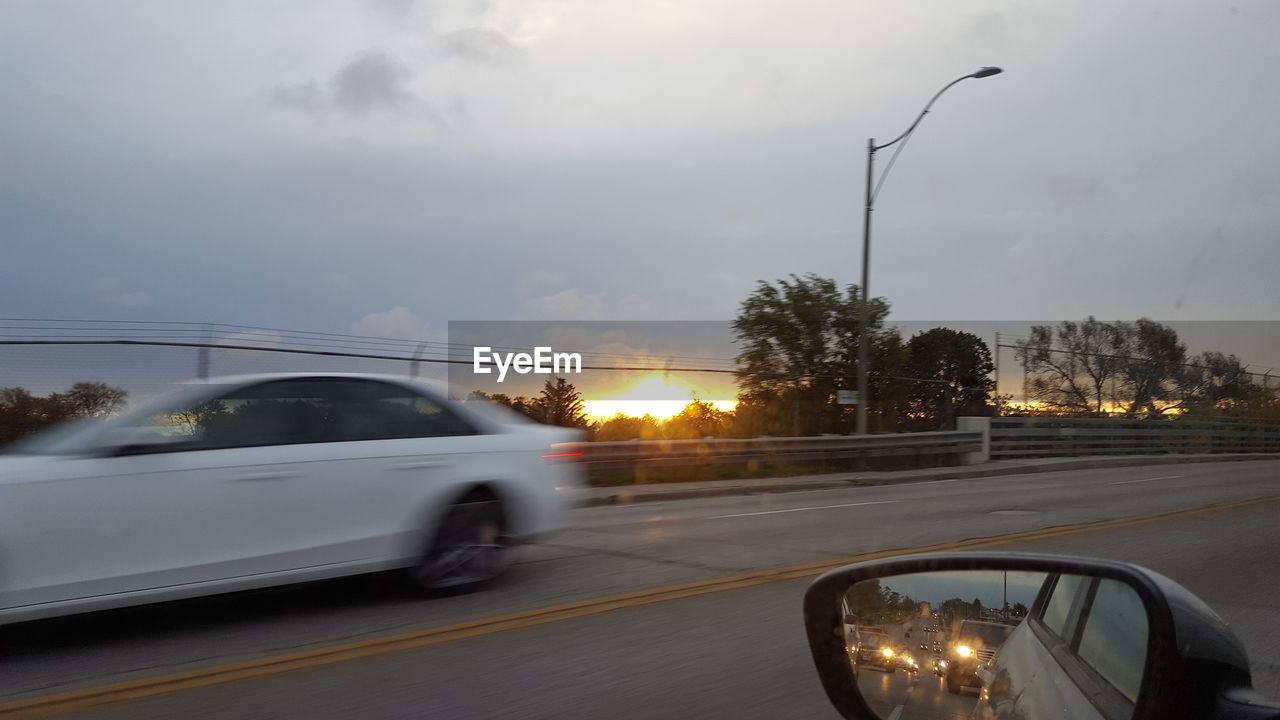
[733,273,901,436]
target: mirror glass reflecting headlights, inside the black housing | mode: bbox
[837,570,1148,720]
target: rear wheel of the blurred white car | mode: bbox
[411,496,509,593]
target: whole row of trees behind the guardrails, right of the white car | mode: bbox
[486,273,1280,441]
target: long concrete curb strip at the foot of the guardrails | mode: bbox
[577,454,1280,507]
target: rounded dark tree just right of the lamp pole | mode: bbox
[904,328,996,430]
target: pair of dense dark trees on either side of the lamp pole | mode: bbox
[733,273,995,436]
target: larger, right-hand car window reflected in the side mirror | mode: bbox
[1076,580,1147,701]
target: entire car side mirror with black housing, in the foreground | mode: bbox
[804,552,1280,720]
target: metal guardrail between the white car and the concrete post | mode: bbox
[584,432,983,469]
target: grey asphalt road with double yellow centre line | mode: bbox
[0,461,1280,720]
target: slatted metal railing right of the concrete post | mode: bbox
[991,418,1280,459]
